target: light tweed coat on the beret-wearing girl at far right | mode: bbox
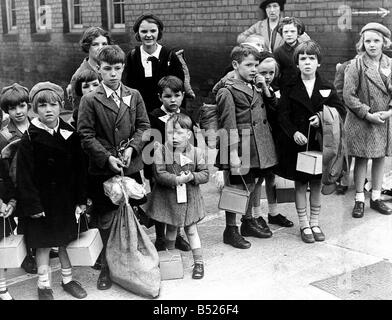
[343,54,392,158]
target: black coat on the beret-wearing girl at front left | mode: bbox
[16,119,87,248]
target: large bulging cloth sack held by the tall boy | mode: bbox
[106,199,161,298]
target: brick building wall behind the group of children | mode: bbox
[0,0,392,114]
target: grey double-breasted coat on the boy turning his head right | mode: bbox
[216,79,278,170]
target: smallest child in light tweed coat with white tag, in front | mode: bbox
[147,113,209,279]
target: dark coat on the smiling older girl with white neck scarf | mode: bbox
[122,46,185,112]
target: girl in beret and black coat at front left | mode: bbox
[16,82,87,300]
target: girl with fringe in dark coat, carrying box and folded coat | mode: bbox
[277,40,345,243]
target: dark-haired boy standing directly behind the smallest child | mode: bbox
[144,76,195,251]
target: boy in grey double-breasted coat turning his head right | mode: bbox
[216,45,277,249]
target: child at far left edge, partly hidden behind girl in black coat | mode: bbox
[0,83,37,274]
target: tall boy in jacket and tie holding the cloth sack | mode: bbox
[78,45,150,290]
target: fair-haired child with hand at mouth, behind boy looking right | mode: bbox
[252,52,294,228]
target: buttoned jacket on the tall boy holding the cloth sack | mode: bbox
[78,84,150,176]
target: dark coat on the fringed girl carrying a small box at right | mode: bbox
[276,74,345,182]
